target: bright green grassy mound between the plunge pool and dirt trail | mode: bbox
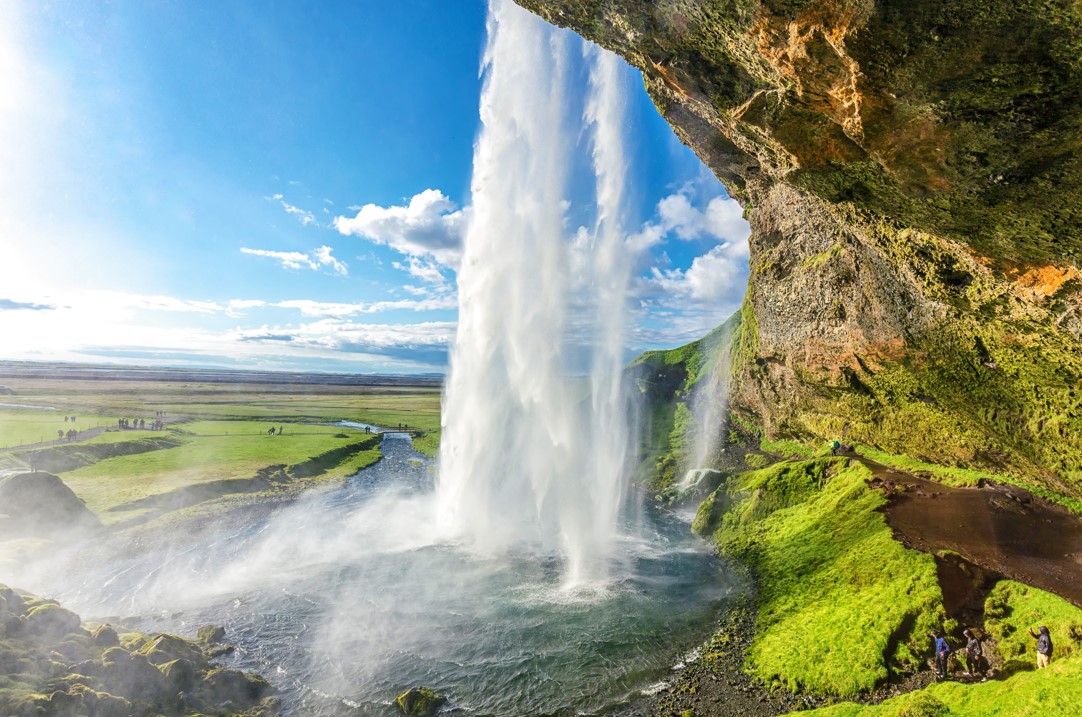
[696,457,944,696]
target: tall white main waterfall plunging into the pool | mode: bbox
[439,0,634,584]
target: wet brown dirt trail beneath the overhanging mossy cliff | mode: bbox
[854,456,1082,611]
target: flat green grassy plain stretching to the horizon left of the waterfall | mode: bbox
[0,367,440,523]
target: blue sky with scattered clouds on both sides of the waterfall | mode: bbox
[0,0,747,373]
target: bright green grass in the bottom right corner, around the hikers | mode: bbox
[801,581,1082,717]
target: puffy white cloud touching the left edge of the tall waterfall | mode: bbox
[334,189,469,267]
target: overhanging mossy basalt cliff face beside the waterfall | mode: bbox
[516,0,1082,497]
